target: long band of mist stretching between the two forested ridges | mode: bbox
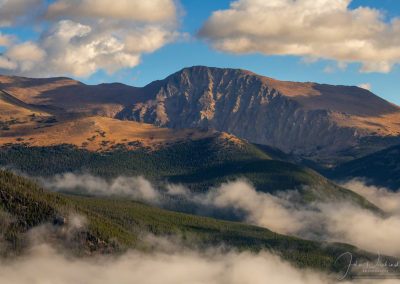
[42,173,400,256]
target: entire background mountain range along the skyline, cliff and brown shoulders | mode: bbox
[0,66,400,167]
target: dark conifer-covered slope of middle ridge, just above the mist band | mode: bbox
[0,133,379,211]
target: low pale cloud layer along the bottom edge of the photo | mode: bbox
[0,242,334,284]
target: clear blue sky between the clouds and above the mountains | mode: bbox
[0,0,400,105]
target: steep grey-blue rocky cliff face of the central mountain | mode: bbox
[117,67,395,163]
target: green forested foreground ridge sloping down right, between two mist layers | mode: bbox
[0,170,382,272]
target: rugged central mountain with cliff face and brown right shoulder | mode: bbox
[117,67,400,162]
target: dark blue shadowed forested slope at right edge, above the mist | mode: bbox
[327,145,400,191]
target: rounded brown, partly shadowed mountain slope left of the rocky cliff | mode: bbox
[0,76,145,117]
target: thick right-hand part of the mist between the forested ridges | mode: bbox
[200,180,400,256]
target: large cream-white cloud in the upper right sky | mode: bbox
[199,0,400,73]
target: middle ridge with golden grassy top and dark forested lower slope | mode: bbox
[0,81,376,211]
